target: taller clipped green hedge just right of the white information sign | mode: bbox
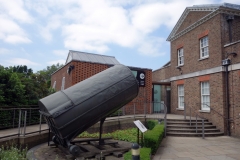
[144,124,164,154]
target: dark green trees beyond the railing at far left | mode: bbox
[0,64,62,106]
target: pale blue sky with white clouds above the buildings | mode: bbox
[0,0,240,72]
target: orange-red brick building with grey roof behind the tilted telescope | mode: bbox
[51,50,152,114]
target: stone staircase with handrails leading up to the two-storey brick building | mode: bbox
[167,119,224,137]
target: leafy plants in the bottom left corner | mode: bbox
[0,145,27,160]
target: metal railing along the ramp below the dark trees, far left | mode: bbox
[0,107,48,139]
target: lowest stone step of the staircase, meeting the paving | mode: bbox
[167,132,224,137]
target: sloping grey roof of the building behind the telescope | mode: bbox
[65,50,120,65]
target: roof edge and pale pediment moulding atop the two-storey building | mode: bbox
[167,3,240,41]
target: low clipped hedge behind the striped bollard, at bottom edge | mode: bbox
[124,148,151,160]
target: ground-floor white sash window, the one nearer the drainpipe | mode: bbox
[201,82,210,110]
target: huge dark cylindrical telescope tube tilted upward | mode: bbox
[38,65,139,147]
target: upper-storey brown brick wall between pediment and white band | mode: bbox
[171,15,222,74]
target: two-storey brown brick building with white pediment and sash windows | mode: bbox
[153,3,240,136]
